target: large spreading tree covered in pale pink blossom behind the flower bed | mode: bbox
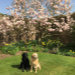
[0,0,74,44]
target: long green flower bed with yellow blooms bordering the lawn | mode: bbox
[0,40,75,56]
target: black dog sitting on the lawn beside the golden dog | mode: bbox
[19,53,30,72]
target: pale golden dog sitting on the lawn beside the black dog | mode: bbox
[30,53,41,73]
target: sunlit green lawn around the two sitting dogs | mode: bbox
[0,53,75,75]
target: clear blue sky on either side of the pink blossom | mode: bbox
[0,0,75,14]
